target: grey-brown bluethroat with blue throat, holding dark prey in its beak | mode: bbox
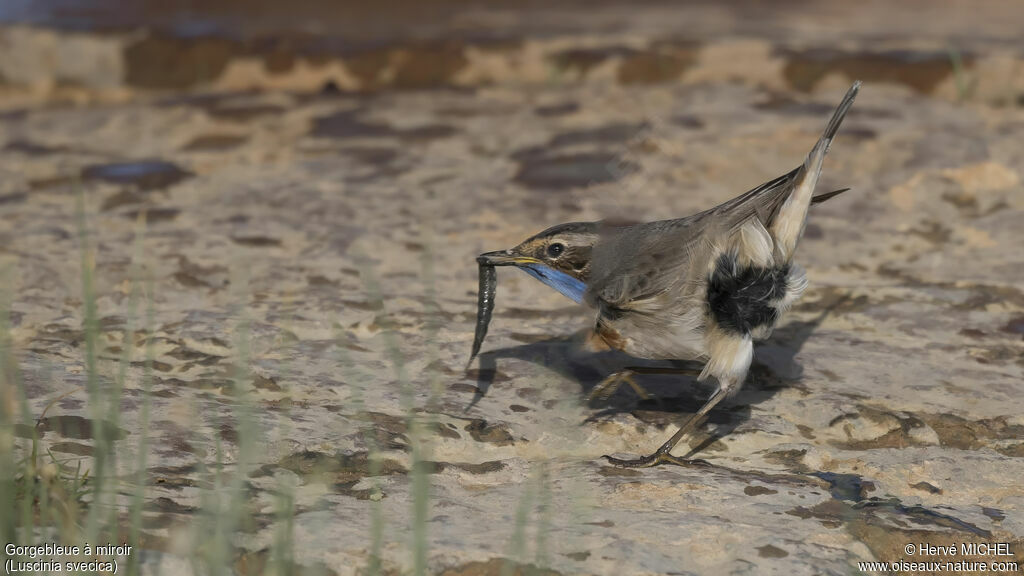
[470,82,860,467]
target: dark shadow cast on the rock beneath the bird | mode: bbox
[466,301,842,454]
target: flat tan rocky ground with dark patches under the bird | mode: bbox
[0,2,1024,574]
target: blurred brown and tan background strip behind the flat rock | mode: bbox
[0,0,1022,98]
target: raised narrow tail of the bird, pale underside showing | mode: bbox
[771,80,860,260]
